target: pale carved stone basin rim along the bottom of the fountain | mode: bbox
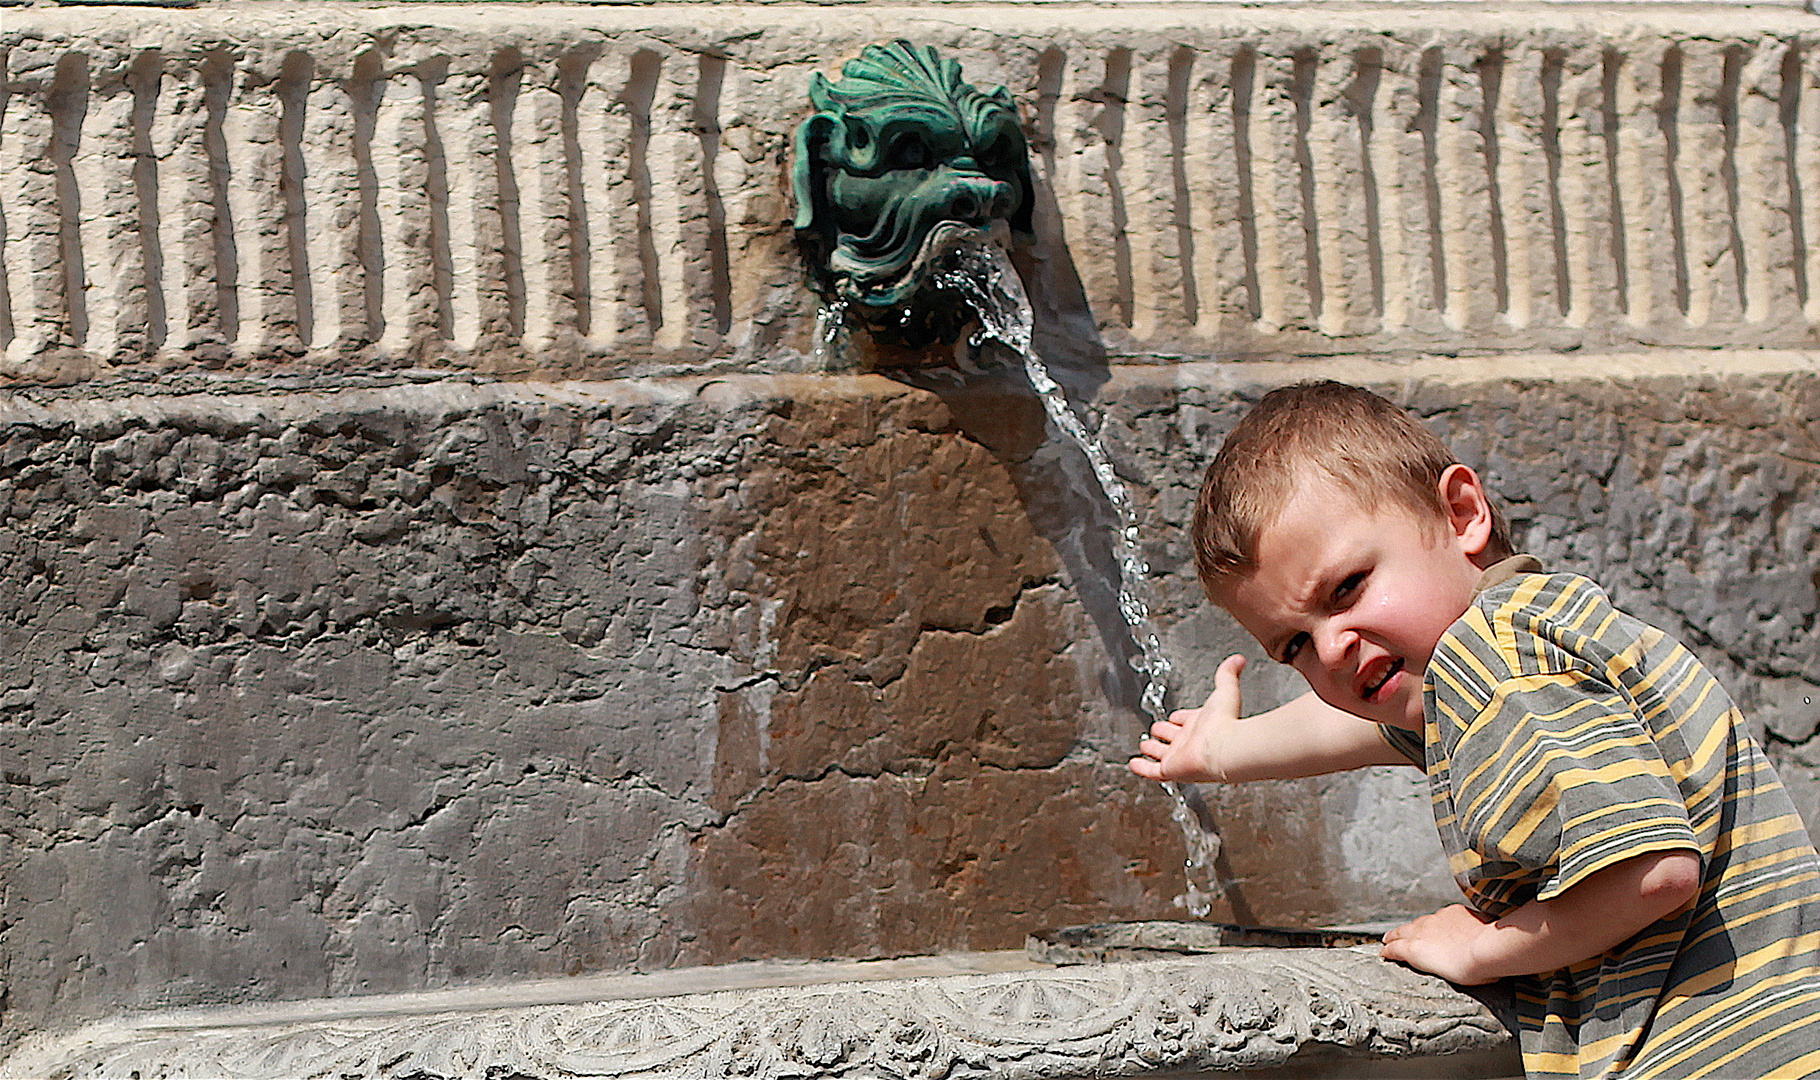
[0,947,1514,1080]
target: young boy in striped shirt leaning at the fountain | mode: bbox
[1130,382,1820,1080]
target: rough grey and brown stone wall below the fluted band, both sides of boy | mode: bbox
[0,355,1820,1027]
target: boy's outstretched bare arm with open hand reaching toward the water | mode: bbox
[1130,654,1409,783]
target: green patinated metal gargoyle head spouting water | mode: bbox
[792,40,1032,346]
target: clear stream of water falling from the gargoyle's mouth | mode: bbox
[935,233,1223,916]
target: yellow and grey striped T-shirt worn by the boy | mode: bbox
[1387,557,1820,1080]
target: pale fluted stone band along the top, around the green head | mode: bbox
[0,4,1820,381]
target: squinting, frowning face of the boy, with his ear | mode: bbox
[1216,464,1491,730]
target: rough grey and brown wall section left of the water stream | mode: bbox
[0,379,1201,1049]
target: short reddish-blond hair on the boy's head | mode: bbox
[1194,381,1511,597]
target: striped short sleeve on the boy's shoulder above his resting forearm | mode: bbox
[1451,670,1700,907]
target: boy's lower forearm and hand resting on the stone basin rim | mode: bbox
[1381,851,1700,985]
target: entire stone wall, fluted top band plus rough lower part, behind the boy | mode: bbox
[0,5,1820,1040]
